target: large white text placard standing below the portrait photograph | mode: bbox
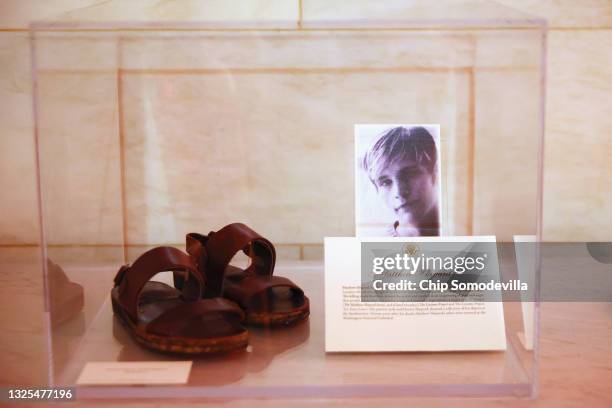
[325,236,506,352]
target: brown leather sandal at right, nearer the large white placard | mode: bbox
[175,223,310,327]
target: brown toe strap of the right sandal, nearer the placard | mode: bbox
[223,275,304,309]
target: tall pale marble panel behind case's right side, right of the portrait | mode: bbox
[474,71,541,242]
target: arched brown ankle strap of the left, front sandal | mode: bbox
[115,247,204,322]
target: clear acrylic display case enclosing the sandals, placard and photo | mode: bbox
[30,0,546,398]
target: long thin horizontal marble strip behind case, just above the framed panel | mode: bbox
[122,31,474,70]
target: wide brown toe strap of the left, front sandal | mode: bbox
[145,298,245,336]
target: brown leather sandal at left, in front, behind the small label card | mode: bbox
[111,247,248,354]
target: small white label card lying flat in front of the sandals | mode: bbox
[77,361,193,385]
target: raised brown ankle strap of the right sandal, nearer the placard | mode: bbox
[187,223,276,298]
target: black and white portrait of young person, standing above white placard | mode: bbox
[355,124,442,237]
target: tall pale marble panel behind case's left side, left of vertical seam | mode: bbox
[38,72,122,245]
